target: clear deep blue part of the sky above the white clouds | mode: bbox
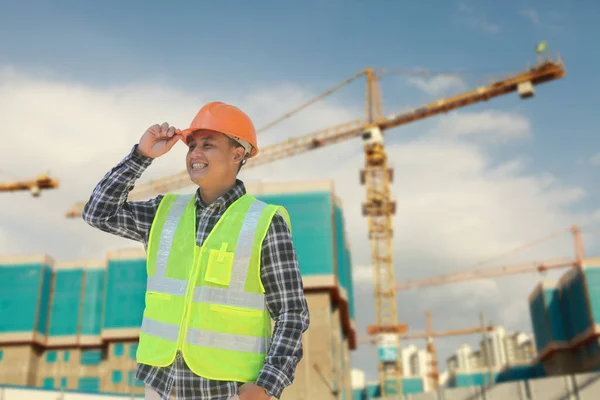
[0,0,600,194]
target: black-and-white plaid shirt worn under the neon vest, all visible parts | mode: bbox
[83,145,309,400]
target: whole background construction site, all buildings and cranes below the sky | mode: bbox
[0,47,600,400]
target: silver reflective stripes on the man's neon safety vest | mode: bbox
[140,195,270,352]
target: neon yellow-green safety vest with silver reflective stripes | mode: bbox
[136,194,291,382]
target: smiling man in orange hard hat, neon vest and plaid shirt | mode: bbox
[83,102,309,400]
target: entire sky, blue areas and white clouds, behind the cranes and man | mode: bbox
[0,0,600,388]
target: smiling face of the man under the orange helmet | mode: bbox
[186,130,244,187]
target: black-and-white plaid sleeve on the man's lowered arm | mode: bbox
[256,214,309,398]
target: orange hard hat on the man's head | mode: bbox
[179,101,258,158]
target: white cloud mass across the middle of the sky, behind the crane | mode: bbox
[0,69,589,382]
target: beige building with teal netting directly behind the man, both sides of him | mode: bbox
[0,181,356,399]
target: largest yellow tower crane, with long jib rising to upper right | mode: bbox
[66,56,565,395]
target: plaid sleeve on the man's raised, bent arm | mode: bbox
[82,144,162,244]
